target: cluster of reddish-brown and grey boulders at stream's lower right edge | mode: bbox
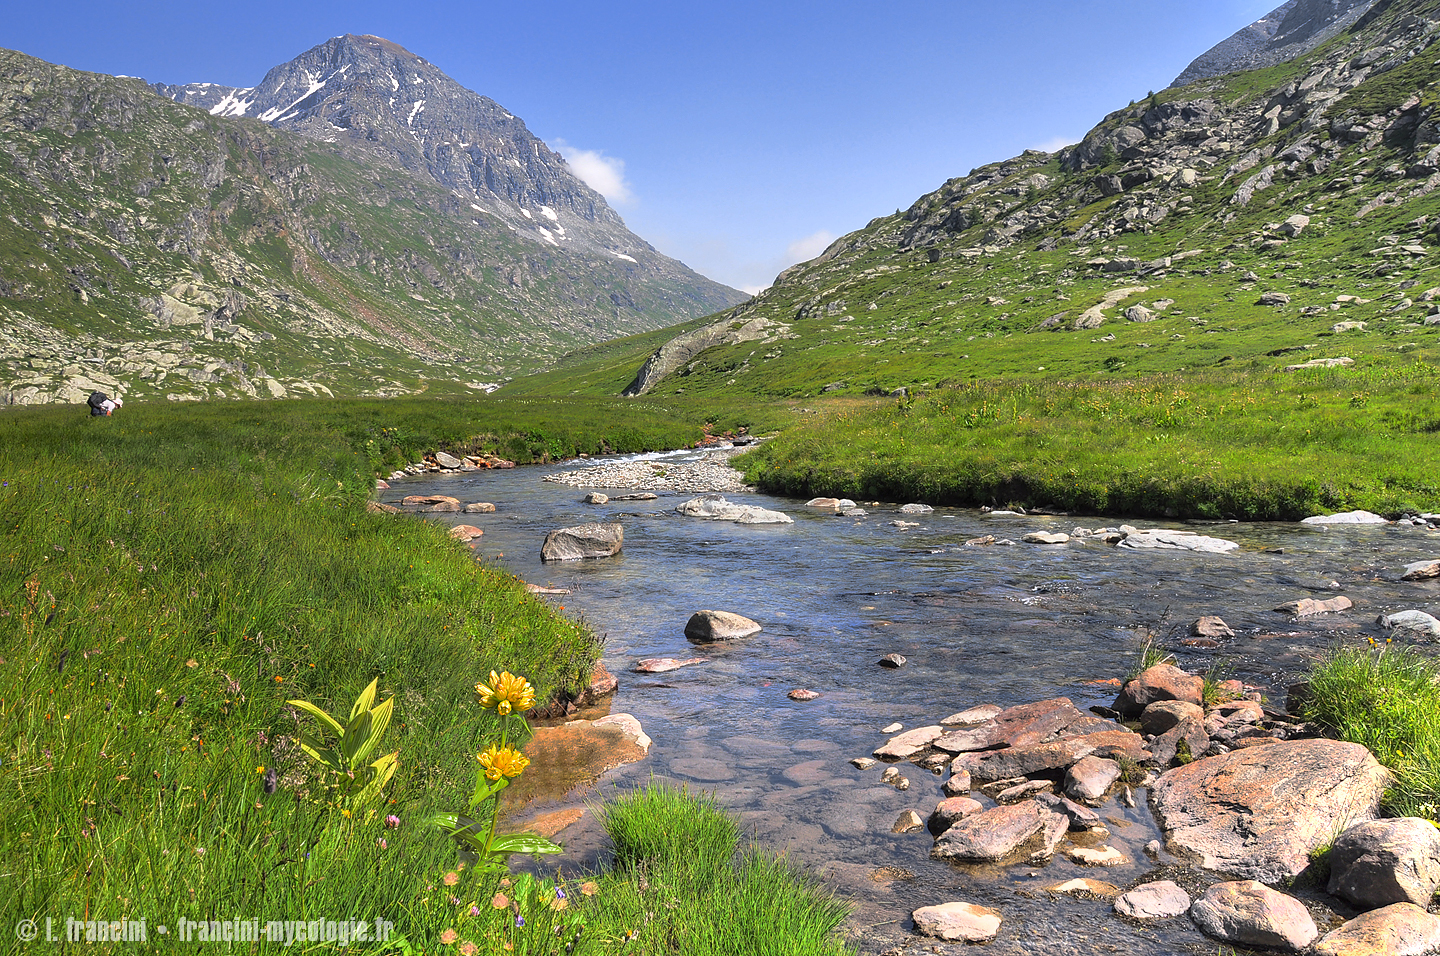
[851,664,1440,955]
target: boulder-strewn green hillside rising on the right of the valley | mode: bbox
[538,0,1440,397]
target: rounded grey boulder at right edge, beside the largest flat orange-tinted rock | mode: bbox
[1326,816,1440,910]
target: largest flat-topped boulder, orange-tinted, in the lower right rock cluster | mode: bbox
[1151,740,1390,883]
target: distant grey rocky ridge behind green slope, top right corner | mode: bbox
[1171,0,1377,86]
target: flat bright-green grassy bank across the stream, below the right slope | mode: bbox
[737,357,1440,520]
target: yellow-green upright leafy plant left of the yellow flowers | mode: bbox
[288,678,400,812]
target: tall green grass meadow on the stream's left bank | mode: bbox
[0,400,852,953]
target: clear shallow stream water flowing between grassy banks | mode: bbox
[383,454,1440,956]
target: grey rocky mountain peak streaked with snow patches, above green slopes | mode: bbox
[153,35,636,262]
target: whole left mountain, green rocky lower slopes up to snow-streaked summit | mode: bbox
[0,36,746,405]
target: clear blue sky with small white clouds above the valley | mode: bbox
[0,0,1280,291]
